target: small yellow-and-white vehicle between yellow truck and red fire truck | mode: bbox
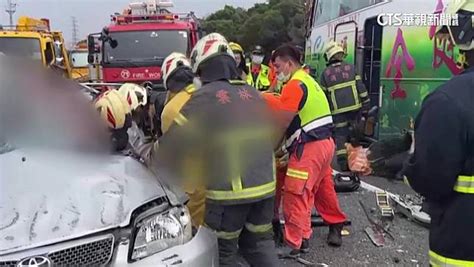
[69,40,90,82]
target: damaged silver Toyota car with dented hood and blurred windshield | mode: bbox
[0,59,218,267]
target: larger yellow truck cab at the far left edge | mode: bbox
[0,16,72,79]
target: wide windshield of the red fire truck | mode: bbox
[104,30,188,63]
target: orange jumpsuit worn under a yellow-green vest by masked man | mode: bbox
[263,77,346,249]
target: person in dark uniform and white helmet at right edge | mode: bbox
[405,0,474,266]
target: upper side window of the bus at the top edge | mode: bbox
[313,0,385,25]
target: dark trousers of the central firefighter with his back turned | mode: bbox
[205,197,279,266]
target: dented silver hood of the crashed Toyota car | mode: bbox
[0,150,166,255]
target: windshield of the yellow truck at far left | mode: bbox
[0,37,41,60]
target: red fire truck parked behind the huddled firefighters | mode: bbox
[88,0,202,90]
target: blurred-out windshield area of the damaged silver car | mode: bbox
[0,56,110,154]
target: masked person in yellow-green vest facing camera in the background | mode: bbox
[247,45,270,91]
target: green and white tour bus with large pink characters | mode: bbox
[305,0,462,140]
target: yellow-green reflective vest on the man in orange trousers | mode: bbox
[286,69,333,151]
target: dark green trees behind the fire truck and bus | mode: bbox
[202,0,305,60]
